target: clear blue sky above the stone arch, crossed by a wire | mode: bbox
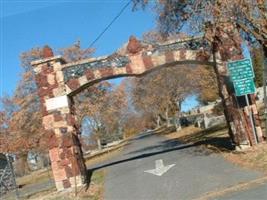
[0,0,199,111]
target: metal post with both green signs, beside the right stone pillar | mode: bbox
[227,58,258,144]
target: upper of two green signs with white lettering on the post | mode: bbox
[227,58,254,81]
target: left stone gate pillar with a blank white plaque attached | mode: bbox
[32,56,86,190]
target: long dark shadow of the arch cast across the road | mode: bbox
[87,126,234,187]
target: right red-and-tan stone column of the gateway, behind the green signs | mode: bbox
[214,21,262,149]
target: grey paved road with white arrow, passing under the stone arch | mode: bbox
[89,133,262,200]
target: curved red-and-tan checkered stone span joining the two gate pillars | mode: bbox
[62,50,213,95]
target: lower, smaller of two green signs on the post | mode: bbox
[233,79,256,96]
